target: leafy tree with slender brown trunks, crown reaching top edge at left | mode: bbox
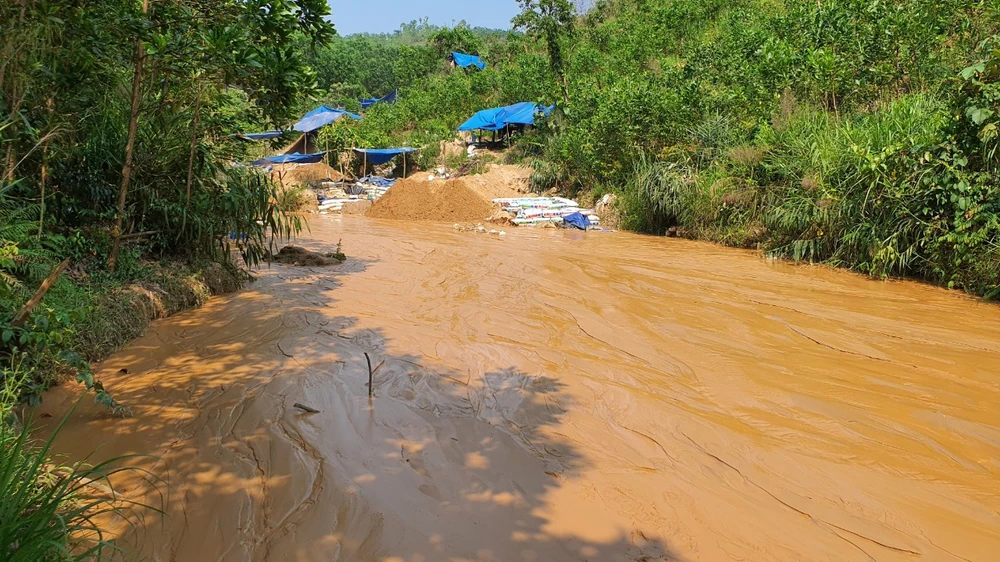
[108,0,334,269]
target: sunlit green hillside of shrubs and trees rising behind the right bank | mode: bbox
[312,0,1000,297]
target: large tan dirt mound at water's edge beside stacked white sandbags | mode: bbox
[366,178,495,222]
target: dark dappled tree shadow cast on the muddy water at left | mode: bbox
[43,260,674,562]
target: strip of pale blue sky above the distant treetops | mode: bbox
[329,0,519,35]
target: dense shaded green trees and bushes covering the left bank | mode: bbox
[0,0,324,415]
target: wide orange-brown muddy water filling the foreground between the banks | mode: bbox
[44,217,1000,562]
